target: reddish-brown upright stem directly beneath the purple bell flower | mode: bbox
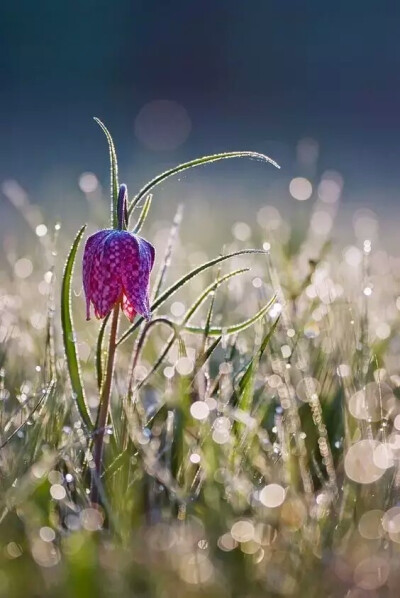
[90,303,119,503]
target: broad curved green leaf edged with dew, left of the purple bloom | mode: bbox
[61,224,93,430]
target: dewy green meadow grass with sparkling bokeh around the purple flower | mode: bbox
[0,127,400,598]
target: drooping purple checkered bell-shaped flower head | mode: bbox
[83,185,155,322]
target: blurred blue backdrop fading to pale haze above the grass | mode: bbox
[0,0,400,250]
